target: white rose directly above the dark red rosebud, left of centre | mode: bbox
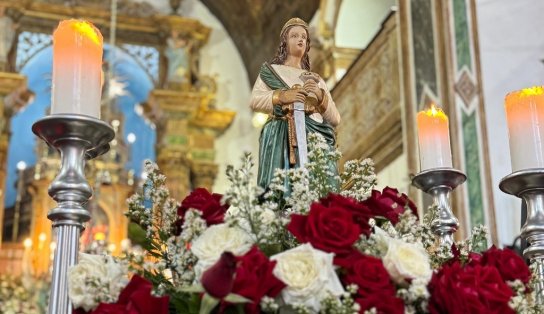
[191,224,253,278]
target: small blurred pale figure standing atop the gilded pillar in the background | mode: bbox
[164,30,191,89]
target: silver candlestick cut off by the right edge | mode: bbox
[499,168,544,304]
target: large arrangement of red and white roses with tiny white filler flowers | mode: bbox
[69,135,543,314]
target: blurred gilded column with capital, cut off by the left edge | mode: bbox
[0,72,26,247]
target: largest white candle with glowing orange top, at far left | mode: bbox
[51,20,103,118]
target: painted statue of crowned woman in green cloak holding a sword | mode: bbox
[250,18,340,188]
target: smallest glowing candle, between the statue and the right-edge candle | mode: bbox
[417,104,452,171]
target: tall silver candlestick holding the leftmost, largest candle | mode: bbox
[32,114,115,314]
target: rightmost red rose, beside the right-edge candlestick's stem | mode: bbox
[479,245,531,284]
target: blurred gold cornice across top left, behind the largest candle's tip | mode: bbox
[3,0,211,53]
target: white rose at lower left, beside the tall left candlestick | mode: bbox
[68,253,128,312]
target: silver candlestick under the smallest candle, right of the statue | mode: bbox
[412,168,467,246]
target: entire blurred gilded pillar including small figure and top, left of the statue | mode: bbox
[145,15,235,200]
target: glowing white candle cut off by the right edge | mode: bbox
[504,86,544,171]
